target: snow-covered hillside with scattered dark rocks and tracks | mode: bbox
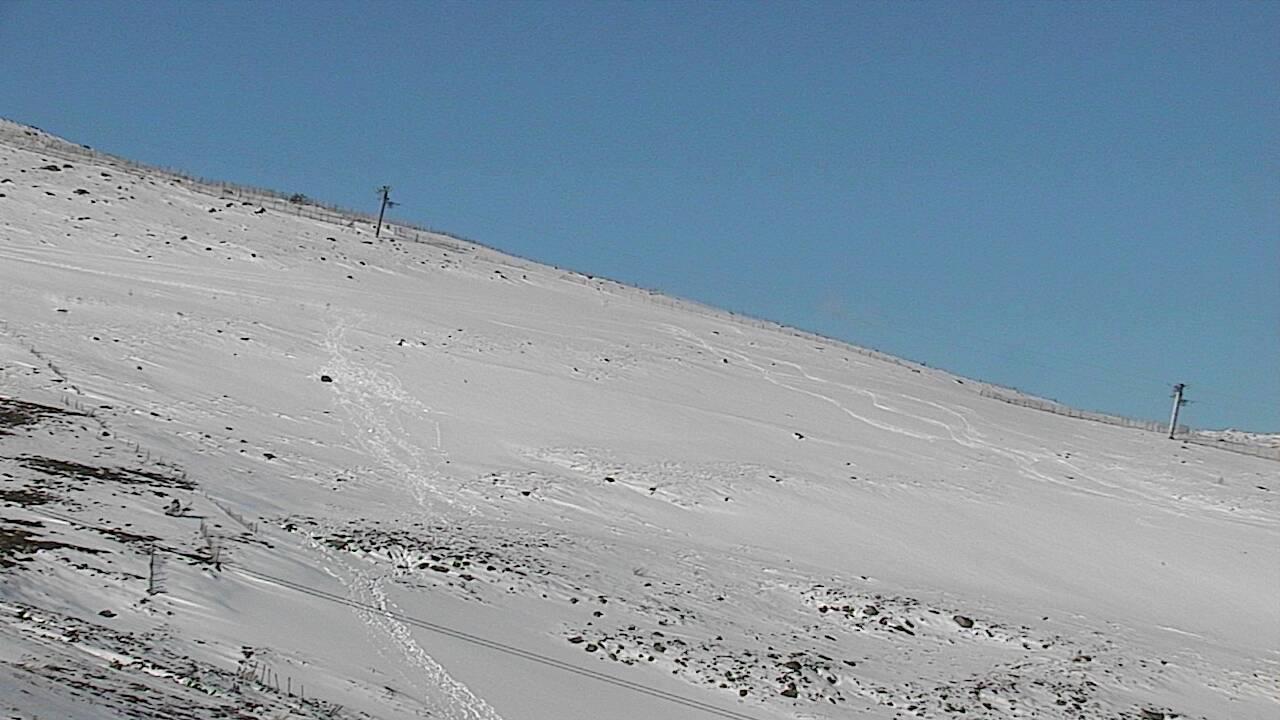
[0,124,1280,720]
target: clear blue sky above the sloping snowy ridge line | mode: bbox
[0,0,1280,430]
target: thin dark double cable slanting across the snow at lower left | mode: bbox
[33,509,756,720]
